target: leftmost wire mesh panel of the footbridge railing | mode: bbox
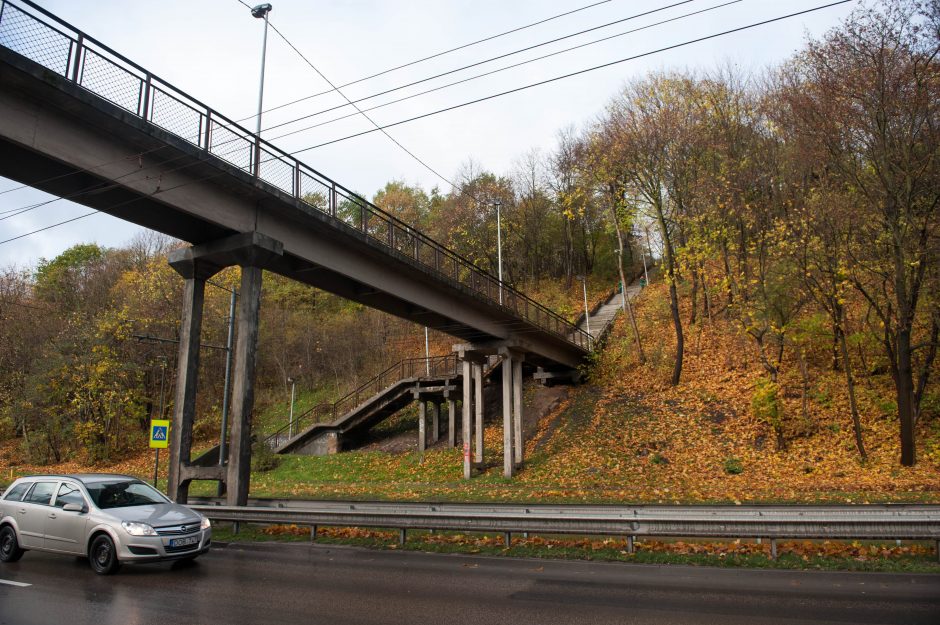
[0,3,72,76]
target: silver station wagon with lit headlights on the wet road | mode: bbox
[0,474,212,575]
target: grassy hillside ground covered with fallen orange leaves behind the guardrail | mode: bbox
[0,284,940,503]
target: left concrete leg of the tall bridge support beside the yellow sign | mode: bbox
[167,260,220,503]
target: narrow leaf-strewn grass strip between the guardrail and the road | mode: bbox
[213,524,940,573]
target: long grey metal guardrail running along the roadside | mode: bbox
[190,499,940,547]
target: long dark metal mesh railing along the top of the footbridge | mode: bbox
[0,0,592,351]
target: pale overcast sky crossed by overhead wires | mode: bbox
[0,0,856,266]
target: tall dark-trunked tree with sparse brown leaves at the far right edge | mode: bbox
[787,0,940,466]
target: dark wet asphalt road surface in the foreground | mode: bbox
[0,544,940,625]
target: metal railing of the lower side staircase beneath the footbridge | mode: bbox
[264,354,459,447]
